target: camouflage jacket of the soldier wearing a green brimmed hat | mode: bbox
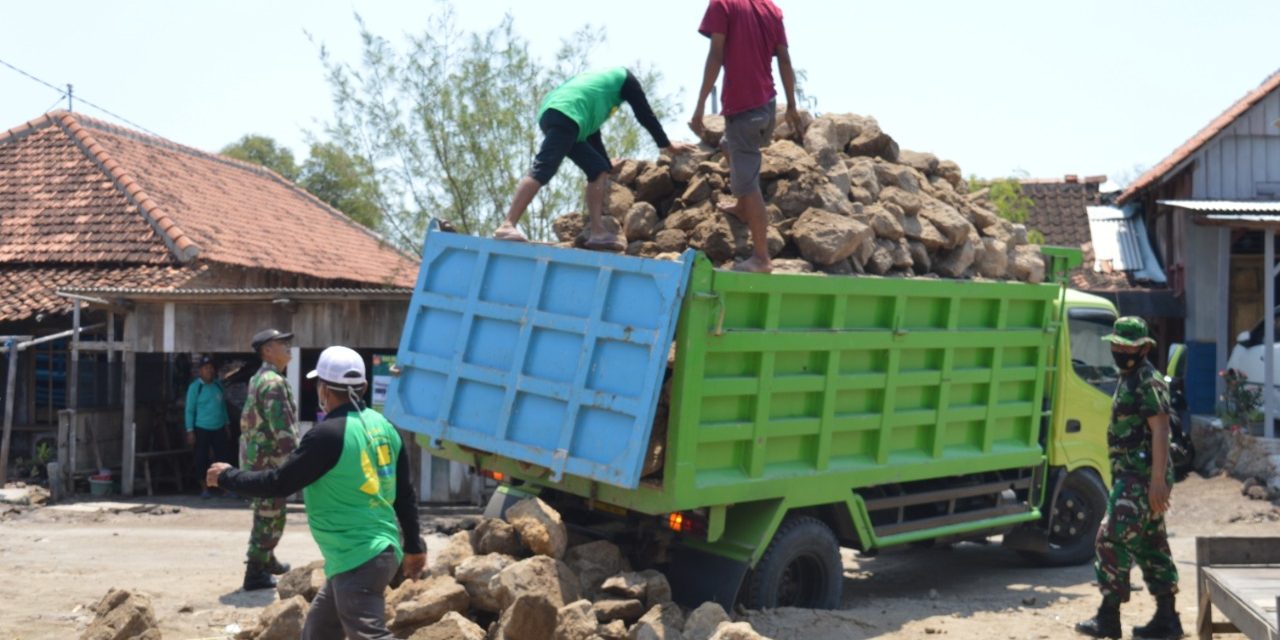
[1107,361,1172,484]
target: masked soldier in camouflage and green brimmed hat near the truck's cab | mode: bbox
[1075,316,1183,639]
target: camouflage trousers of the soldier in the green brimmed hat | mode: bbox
[1093,477,1178,604]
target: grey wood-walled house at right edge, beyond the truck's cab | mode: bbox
[1117,66,1280,425]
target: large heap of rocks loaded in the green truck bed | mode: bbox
[553,107,1044,282]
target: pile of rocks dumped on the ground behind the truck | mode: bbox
[238,498,764,640]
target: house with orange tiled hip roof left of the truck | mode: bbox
[0,111,430,494]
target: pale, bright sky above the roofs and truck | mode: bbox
[0,0,1280,183]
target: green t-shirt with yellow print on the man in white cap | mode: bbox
[303,408,404,577]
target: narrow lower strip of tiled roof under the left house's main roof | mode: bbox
[0,264,200,323]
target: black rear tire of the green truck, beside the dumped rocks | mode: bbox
[741,516,845,609]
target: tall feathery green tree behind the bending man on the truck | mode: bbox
[320,3,672,248]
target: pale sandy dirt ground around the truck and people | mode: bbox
[0,476,1280,640]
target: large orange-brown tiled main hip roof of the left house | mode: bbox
[0,111,417,287]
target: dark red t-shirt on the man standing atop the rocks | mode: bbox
[698,0,787,115]
